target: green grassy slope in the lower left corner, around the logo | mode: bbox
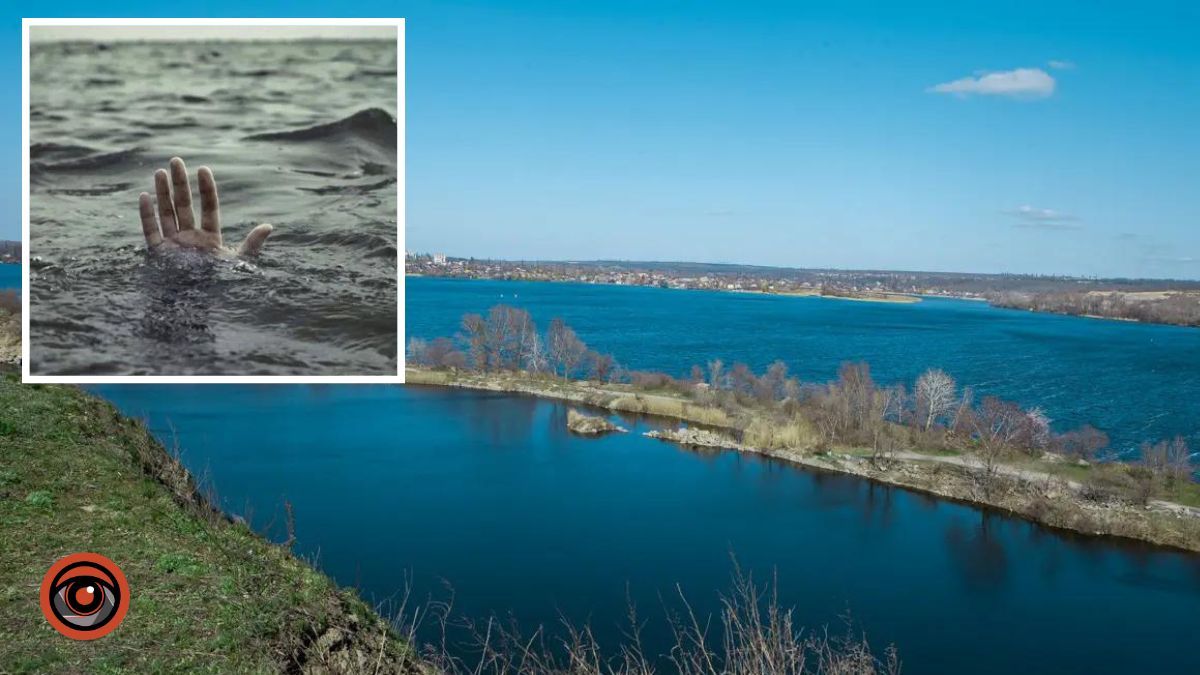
[0,378,409,673]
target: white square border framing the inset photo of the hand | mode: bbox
[20,18,406,384]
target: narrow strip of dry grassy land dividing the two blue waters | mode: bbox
[406,368,1200,552]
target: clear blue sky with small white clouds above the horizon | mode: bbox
[7,1,1200,279]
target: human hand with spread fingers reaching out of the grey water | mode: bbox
[138,157,272,257]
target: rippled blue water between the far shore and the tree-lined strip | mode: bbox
[406,277,1200,452]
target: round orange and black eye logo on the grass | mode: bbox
[38,554,130,640]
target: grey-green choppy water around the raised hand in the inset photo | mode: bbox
[30,42,397,375]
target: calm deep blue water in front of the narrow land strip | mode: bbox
[97,386,1200,675]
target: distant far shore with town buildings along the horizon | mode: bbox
[404,253,1200,325]
